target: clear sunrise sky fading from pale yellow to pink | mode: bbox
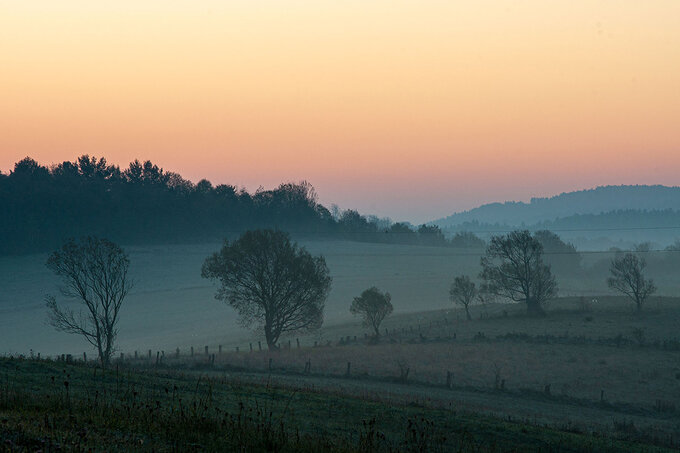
[0,0,680,223]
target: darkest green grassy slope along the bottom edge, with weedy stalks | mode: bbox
[0,359,666,452]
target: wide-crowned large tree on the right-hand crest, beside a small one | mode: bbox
[480,230,557,315]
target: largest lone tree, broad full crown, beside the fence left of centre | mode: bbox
[201,230,331,350]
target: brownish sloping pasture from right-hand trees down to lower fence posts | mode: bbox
[142,297,680,410]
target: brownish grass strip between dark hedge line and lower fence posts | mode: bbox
[195,342,680,409]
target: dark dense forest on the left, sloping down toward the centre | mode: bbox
[0,155,462,254]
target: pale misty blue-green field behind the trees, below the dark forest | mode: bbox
[0,241,677,356]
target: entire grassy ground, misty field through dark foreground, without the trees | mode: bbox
[0,242,680,451]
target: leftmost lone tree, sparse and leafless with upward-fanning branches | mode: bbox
[46,237,132,367]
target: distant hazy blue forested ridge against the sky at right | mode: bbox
[432,185,680,228]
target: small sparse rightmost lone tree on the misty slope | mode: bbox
[607,253,656,312]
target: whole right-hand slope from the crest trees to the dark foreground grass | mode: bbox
[95,297,680,445]
